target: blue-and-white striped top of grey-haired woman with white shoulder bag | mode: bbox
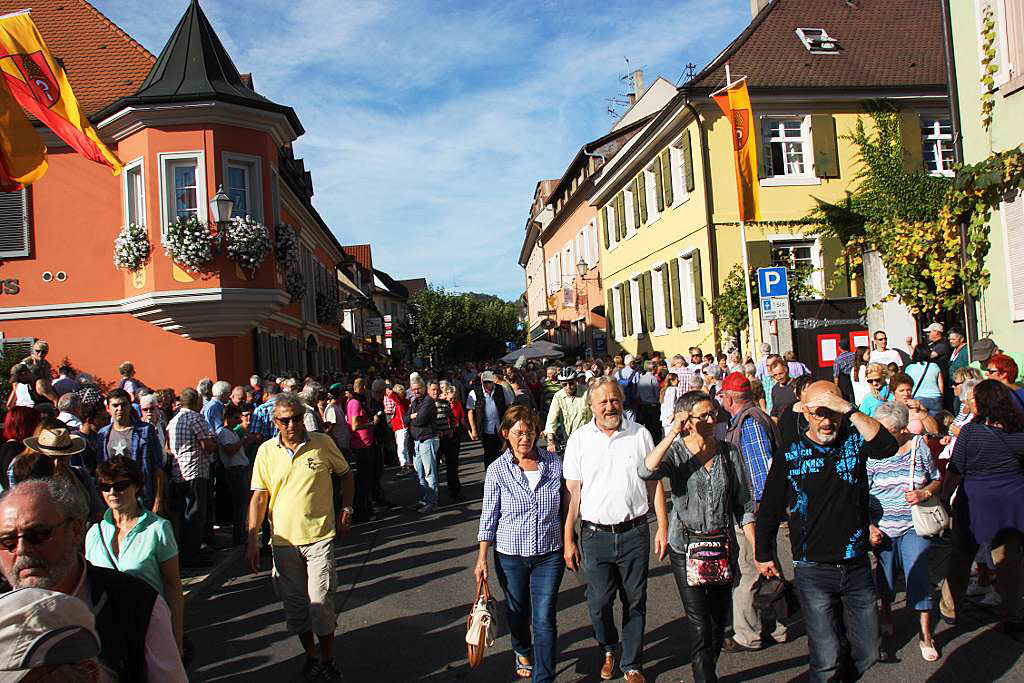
[867,436,939,539]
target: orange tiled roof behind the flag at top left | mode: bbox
[0,0,156,118]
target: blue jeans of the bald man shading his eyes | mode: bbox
[796,557,879,681]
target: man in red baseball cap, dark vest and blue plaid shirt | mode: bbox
[722,373,787,652]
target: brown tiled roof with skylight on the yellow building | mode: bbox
[682,0,946,91]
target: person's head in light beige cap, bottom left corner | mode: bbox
[0,588,104,683]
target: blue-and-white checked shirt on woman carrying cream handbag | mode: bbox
[477,449,562,557]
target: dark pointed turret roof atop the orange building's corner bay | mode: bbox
[105,0,305,135]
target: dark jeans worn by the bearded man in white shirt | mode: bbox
[581,524,650,672]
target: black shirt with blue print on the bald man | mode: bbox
[755,422,898,563]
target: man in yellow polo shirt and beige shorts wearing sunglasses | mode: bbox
[246,394,355,681]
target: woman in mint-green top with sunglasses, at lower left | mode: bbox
[85,456,184,652]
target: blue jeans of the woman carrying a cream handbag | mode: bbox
[495,550,565,683]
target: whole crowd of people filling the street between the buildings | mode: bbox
[0,324,1024,683]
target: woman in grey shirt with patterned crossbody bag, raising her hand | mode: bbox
[637,391,754,683]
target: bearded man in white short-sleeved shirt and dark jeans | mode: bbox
[562,377,669,683]
